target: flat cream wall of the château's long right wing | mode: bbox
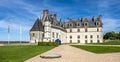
[66,27,103,43]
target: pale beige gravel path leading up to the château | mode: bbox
[25,45,120,62]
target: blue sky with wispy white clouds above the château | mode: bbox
[0,0,120,41]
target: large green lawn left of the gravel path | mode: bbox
[0,45,55,62]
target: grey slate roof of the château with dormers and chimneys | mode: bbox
[30,11,103,31]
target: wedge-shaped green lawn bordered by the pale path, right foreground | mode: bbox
[72,45,120,54]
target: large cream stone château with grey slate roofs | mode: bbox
[30,10,103,43]
